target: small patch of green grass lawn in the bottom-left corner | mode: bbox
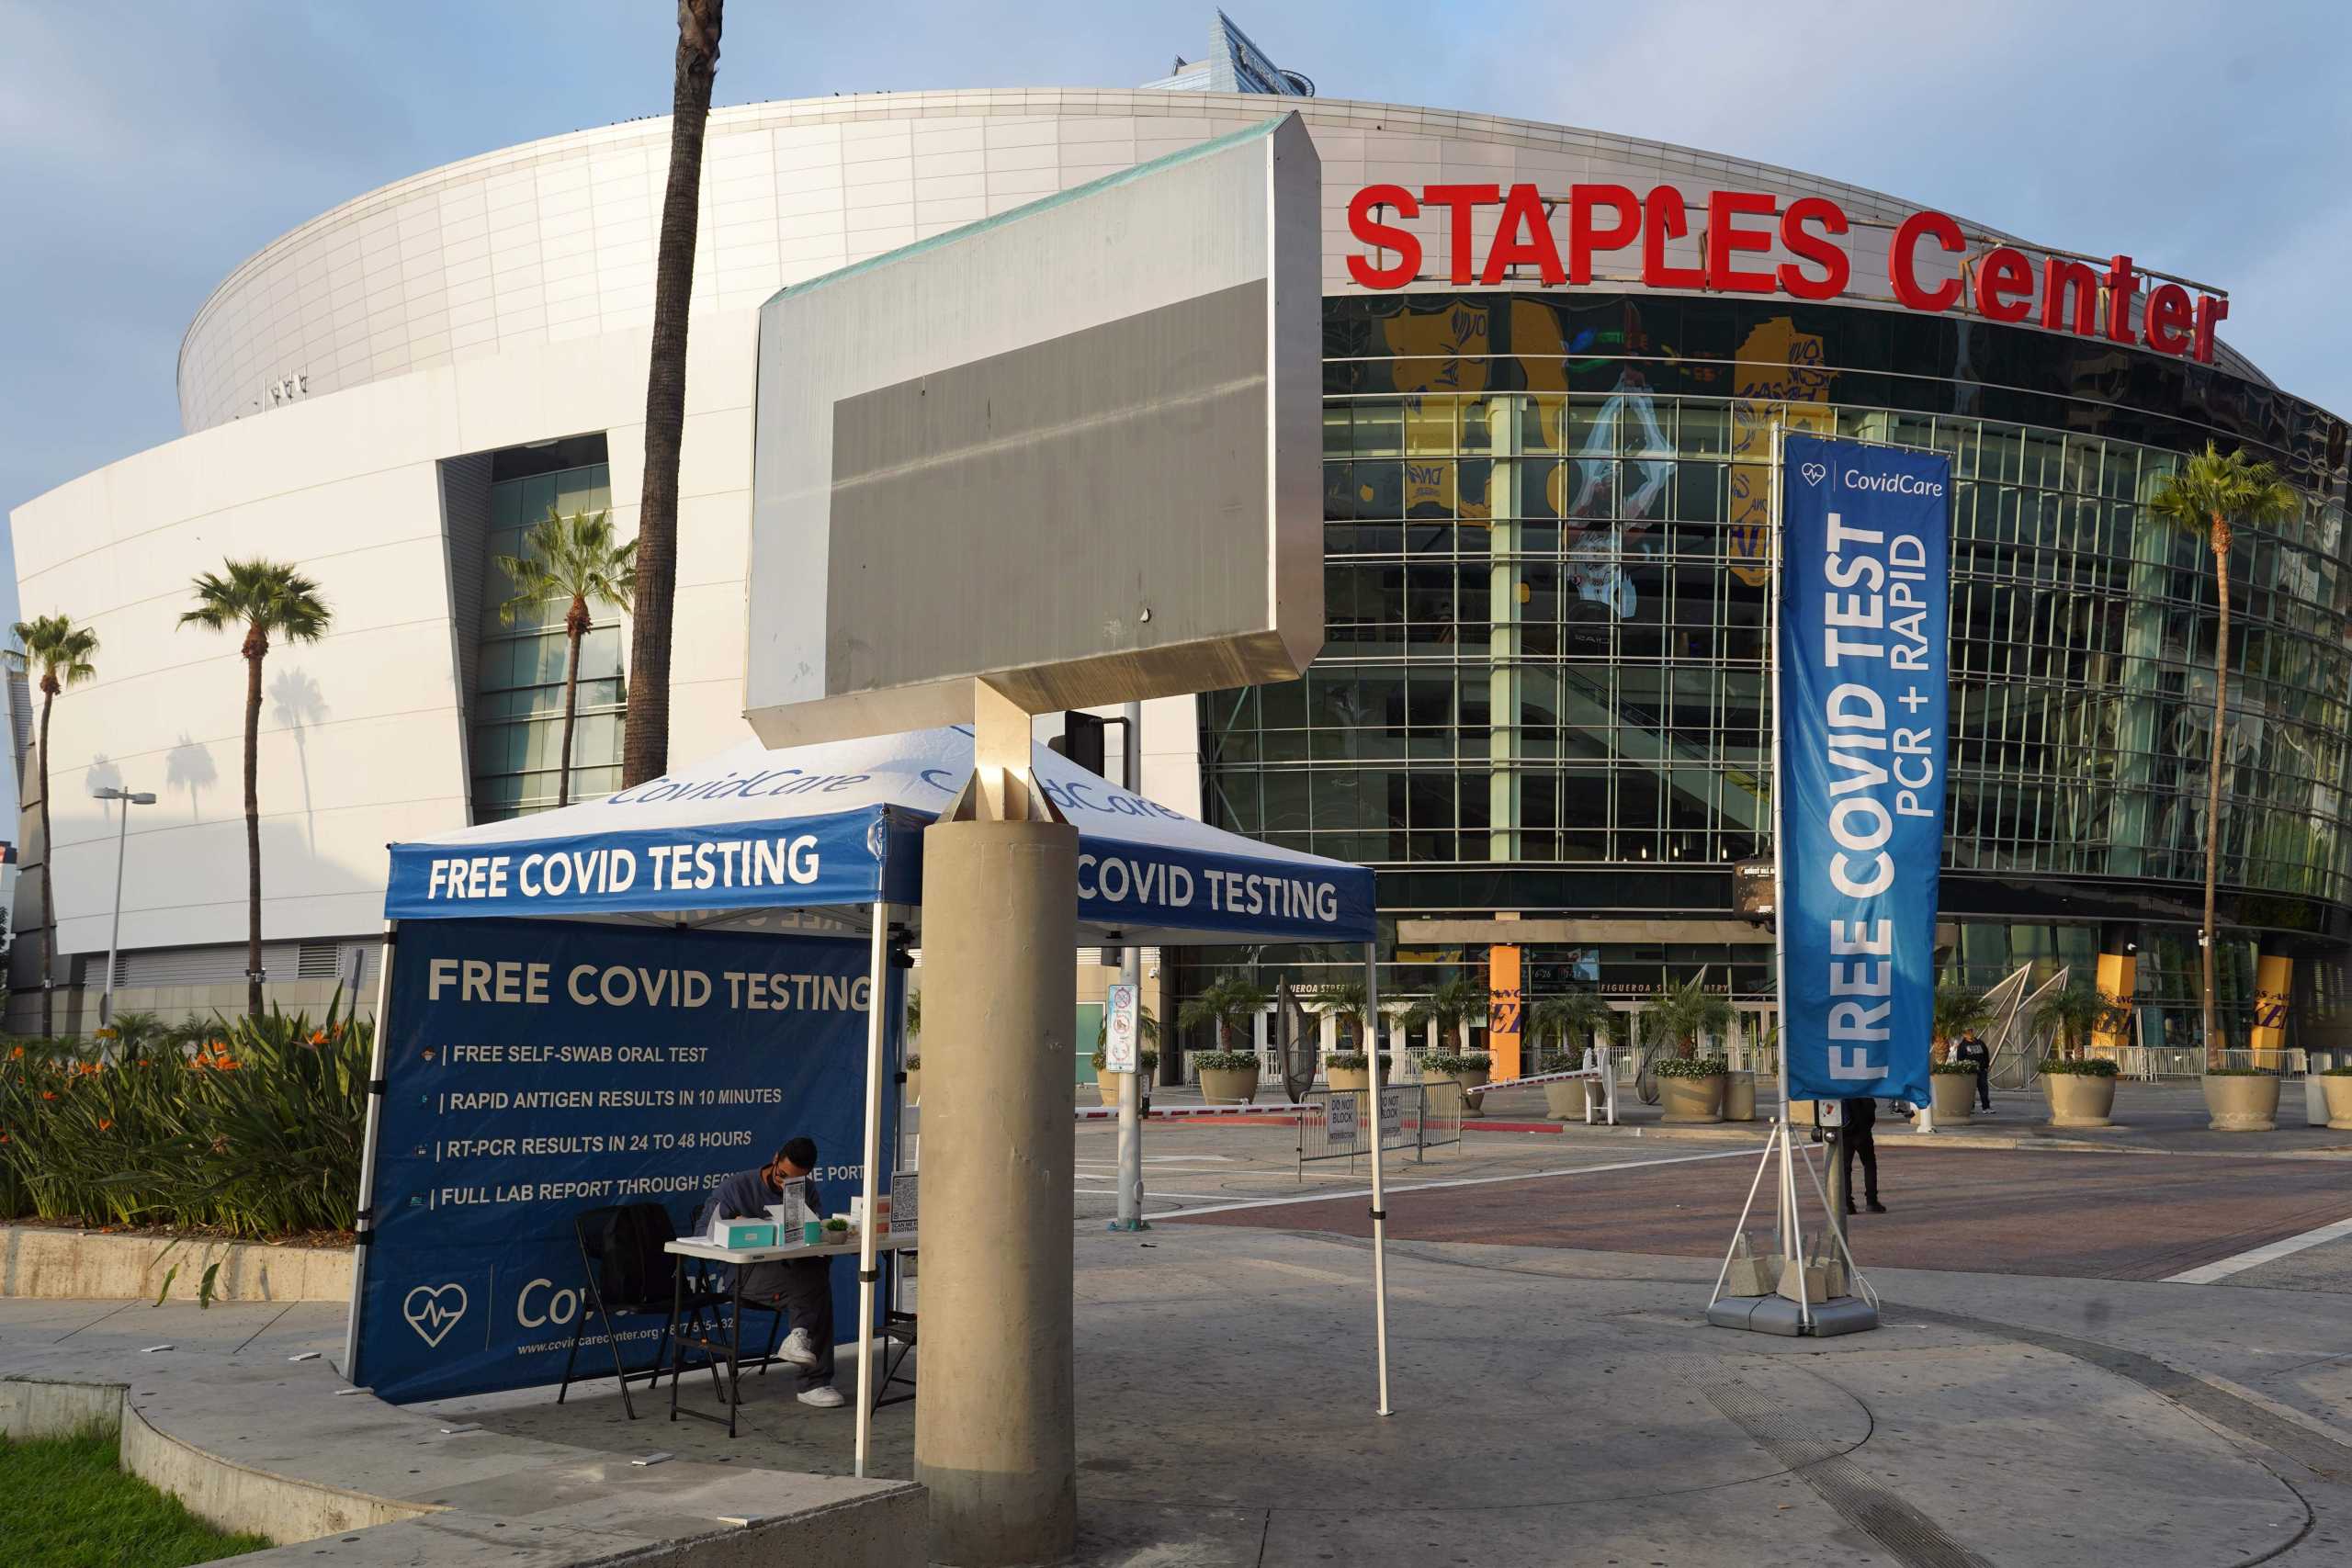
[0,1432,270,1568]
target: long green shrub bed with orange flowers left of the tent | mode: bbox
[0,1004,374,1236]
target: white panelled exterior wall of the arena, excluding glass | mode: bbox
[12,89,2244,1024]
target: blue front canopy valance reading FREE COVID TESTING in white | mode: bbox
[383,808,889,919]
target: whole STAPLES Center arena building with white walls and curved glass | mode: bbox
[12,17,2352,1062]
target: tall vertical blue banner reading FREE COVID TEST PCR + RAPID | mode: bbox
[1776,434,1952,1105]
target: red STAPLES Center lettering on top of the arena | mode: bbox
[1348,186,2230,365]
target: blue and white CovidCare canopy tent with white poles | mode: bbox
[345,727,1387,1474]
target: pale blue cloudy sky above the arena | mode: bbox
[0,0,2352,639]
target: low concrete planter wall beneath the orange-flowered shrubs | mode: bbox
[0,1224,350,1303]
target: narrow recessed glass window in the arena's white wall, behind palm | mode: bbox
[468,463,628,823]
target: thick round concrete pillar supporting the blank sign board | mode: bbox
[915,820,1077,1568]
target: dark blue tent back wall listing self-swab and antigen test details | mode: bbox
[350,919,896,1404]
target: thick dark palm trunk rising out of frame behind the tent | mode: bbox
[621,0,724,785]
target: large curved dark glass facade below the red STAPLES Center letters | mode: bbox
[1185,291,2352,1053]
